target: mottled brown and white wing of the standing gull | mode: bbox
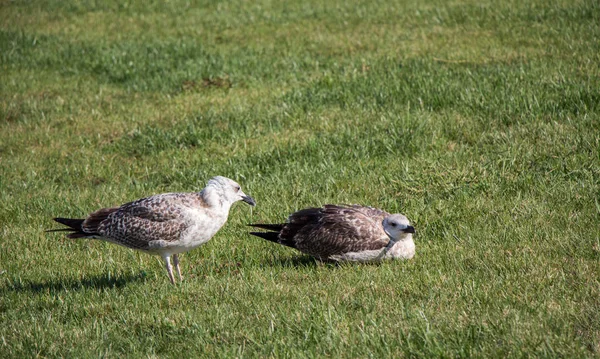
[98,193,191,249]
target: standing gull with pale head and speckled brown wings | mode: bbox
[49,176,256,284]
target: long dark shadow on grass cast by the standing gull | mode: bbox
[0,272,146,293]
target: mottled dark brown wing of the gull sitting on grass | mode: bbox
[280,205,389,259]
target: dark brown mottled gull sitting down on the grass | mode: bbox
[250,204,415,262]
